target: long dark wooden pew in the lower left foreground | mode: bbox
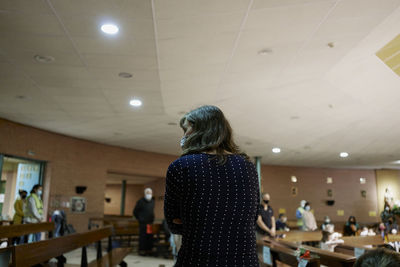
[10,227,131,267]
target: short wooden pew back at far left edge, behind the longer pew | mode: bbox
[0,222,54,246]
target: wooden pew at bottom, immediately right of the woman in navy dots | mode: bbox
[257,241,320,267]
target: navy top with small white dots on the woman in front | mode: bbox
[164,153,259,267]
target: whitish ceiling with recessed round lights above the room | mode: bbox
[0,0,400,168]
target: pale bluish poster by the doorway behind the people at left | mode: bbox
[14,163,40,199]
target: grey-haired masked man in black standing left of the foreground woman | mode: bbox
[133,188,154,256]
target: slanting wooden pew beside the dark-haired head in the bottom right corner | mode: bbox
[275,240,356,267]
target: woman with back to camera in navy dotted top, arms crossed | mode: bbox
[164,106,260,267]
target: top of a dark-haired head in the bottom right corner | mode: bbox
[354,248,400,267]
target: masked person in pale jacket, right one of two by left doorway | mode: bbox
[24,184,43,242]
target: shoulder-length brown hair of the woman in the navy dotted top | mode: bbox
[180,106,249,164]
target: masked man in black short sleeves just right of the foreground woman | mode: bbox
[257,193,276,239]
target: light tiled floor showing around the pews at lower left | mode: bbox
[64,248,174,267]
